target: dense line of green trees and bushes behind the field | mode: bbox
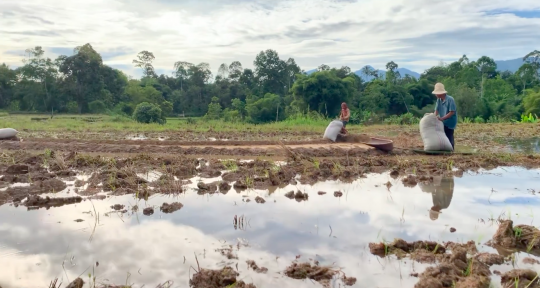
[0,44,540,123]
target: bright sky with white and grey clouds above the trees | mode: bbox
[0,0,540,76]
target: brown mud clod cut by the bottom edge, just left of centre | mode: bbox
[189,266,256,288]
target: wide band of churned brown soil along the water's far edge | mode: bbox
[0,146,540,207]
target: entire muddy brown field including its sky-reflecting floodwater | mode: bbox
[0,127,540,288]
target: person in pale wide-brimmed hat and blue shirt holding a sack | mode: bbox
[433,83,457,150]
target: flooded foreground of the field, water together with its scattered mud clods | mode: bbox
[0,158,540,288]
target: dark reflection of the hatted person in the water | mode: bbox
[418,176,454,220]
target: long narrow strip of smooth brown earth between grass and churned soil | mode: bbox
[0,138,374,156]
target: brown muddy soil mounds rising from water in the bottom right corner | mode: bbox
[369,220,540,288]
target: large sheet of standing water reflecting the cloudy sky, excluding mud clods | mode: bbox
[0,168,540,288]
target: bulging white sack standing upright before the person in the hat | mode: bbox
[420,113,453,151]
